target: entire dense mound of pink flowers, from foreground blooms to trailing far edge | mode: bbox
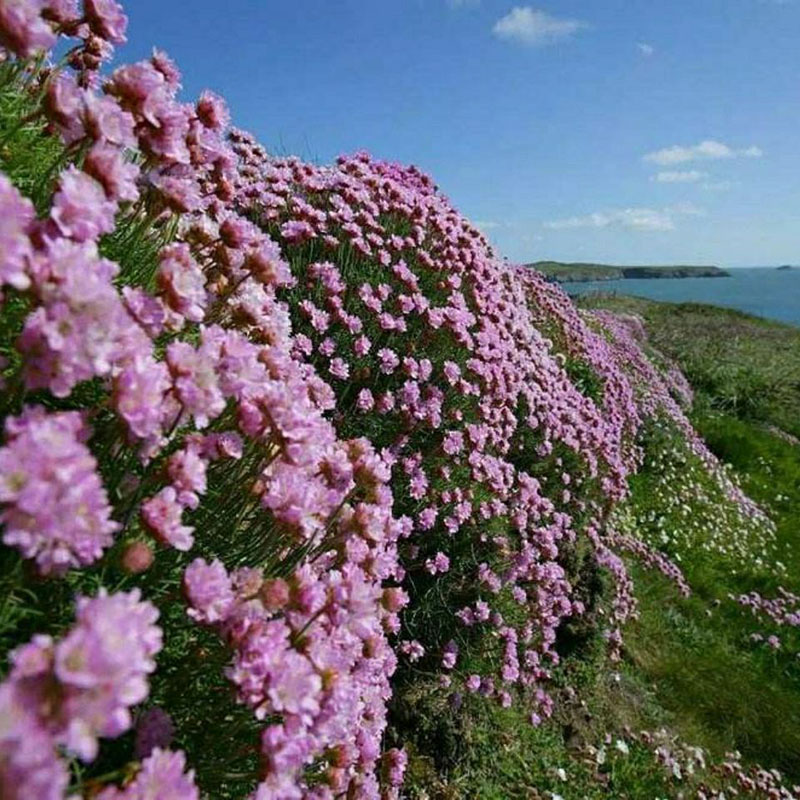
[0,0,776,800]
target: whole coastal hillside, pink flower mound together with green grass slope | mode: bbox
[0,6,800,800]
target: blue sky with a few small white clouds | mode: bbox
[119,0,800,266]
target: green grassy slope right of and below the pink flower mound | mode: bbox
[408,297,800,800]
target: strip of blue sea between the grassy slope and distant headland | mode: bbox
[563,267,800,326]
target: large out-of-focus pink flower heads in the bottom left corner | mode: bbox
[0,589,162,800]
